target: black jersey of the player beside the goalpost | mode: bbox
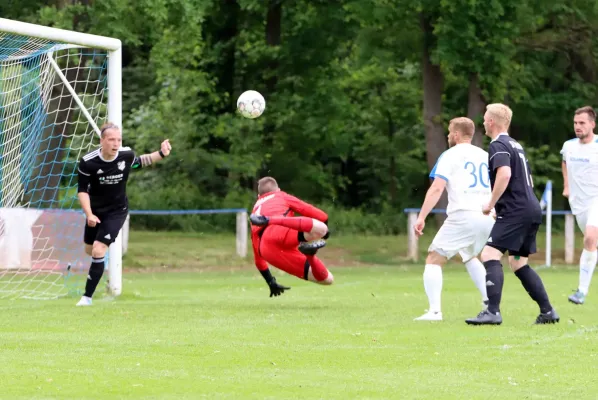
[78,147,141,215]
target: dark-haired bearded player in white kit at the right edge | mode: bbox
[561,106,598,304]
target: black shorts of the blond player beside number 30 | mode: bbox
[486,219,540,257]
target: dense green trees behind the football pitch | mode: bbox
[0,0,598,233]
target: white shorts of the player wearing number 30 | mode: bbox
[428,211,494,262]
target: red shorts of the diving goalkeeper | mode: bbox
[259,225,309,280]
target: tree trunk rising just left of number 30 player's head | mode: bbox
[420,14,448,224]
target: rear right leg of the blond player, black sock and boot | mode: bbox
[509,256,560,324]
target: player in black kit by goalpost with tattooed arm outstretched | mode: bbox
[77,123,171,306]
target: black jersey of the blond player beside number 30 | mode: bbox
[488,134,542,223]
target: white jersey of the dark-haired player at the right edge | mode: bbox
[561,135,598,215]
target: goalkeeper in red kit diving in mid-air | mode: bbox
[249,177,334,297]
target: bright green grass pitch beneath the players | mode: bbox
[0,232,598,399]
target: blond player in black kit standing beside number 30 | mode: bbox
[465,104,559,325]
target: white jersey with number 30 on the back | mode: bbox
[430,143,491,215]
